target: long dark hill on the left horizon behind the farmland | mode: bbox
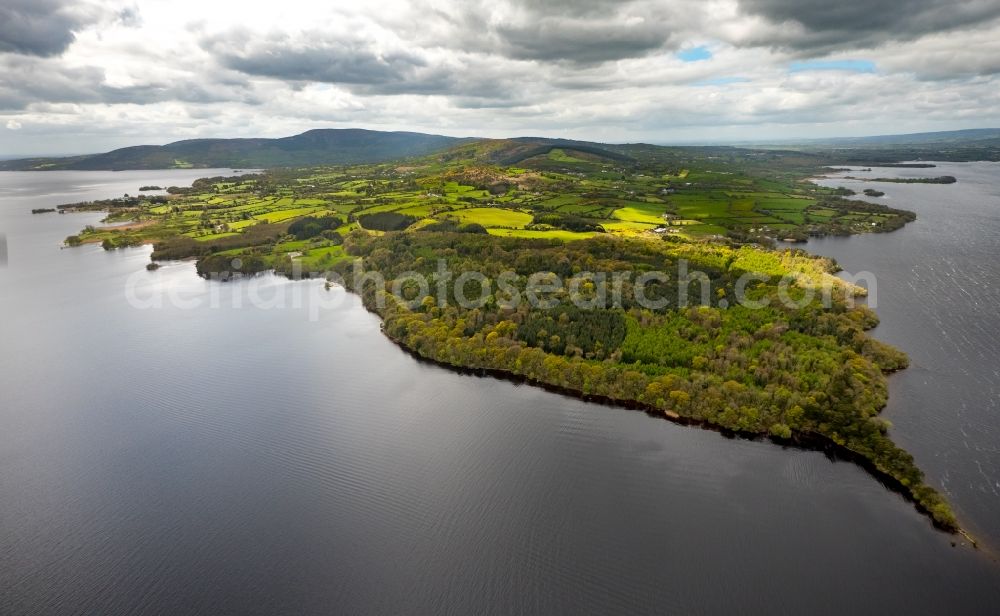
[0,129,466,171]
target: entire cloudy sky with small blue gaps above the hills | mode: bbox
[0,0,1000,156]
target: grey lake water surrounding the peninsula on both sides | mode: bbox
[0,167,1000,615]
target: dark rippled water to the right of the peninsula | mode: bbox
[808,162,1000,549]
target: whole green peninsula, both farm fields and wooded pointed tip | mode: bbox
[60,140,959,531]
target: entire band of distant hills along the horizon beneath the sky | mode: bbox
[0,128,1000,171]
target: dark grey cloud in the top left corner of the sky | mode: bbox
[0,0,99,57]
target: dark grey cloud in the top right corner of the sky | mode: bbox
[740,0,1000,51]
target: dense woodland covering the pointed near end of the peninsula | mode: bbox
[337,233,958,531]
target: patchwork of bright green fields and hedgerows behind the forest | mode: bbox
[64,141,908,267]
